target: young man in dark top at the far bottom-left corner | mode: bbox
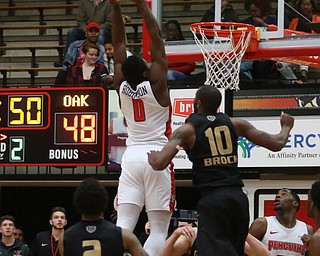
[0,215,29,256]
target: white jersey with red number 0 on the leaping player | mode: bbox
[119,81,171,146]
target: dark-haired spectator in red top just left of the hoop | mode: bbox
[165,20,196,81]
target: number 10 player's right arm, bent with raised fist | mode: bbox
[232,112,294,151]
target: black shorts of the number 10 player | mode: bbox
[197,187,249,256]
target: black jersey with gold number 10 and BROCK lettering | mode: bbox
[186,113,243,189]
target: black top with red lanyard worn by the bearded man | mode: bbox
[30,230,60,256]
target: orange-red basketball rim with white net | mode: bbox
[190,22,258,90]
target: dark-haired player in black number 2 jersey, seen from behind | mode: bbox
[59,178,148,256]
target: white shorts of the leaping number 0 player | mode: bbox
[118,145,175,212]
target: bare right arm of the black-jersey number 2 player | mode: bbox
[121,228,149,256]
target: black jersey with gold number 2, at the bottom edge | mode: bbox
[63,219,125,256]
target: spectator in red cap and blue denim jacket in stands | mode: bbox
[63,22,105,70]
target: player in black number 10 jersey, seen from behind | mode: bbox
[148,85,294,256]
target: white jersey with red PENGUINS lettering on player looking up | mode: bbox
[262,216,308,256]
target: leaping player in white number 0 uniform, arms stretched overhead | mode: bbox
[110,0,175,256]
